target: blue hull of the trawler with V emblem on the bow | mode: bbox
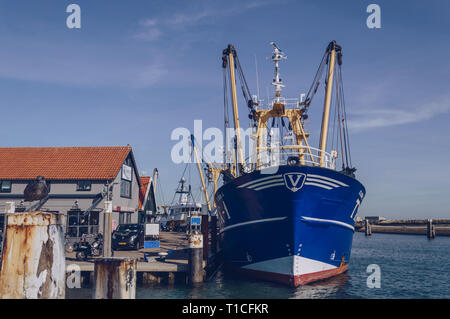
[216,166,365,286]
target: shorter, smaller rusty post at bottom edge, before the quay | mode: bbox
[94,257,137,299]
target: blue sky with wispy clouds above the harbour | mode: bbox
[0,0,450,218]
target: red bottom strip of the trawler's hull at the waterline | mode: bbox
[232,264,348,287]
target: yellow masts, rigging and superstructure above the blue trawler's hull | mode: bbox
[217,41,348,176]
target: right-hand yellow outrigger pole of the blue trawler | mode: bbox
[319,41,341,167]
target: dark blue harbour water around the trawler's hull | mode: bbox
[66,233,450,299]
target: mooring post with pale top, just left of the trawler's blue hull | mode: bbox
[188,232,204,285]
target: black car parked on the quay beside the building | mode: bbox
[112,224,144,250]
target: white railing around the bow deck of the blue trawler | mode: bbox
[246,145,337,172]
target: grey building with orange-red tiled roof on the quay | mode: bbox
[0,146,143,242]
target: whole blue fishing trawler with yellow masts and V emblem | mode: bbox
[215,41,365,286]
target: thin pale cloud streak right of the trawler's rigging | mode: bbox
[348,97,450,131]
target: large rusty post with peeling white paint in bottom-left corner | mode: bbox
[0,212,66,299]
